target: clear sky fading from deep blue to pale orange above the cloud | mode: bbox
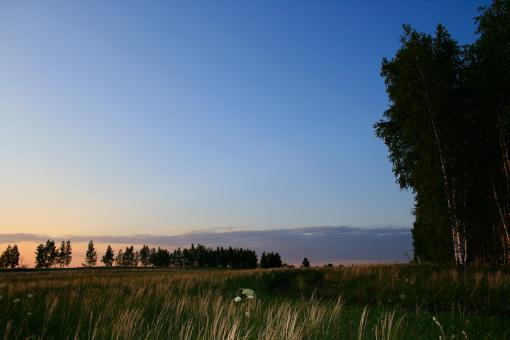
[0,0,487,239]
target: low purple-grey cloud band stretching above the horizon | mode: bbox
[0,226,412,264]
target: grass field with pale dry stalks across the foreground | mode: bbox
[0,265,510,339]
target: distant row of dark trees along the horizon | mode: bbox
[0,240,283,269]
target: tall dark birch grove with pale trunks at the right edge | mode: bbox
[375,0,510,268]
